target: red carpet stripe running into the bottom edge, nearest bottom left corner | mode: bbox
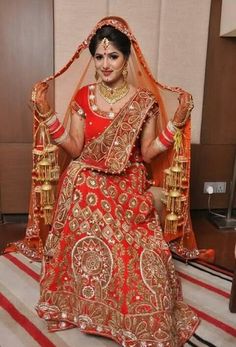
[0,293,56,347]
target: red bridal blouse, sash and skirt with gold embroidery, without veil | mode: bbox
[37,85,198,347]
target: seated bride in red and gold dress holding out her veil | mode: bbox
[30,17,199,347]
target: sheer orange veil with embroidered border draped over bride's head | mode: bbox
[14,16,214,260]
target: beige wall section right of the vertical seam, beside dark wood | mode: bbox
[158,0,211,143]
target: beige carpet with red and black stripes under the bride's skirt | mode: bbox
[0,253,236,347]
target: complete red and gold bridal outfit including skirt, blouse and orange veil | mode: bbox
[6,17,216,347]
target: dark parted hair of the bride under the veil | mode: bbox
[89,25,131,58]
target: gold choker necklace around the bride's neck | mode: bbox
[98,81,129,105]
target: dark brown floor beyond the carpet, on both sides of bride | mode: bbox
[0,210,236,271]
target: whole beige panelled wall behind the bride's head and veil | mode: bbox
[54,0,211,143]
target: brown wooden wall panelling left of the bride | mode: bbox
[0,0,53,214]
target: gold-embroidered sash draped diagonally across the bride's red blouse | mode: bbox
[80,89,155,173]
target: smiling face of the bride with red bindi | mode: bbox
[94,39,126,87]
